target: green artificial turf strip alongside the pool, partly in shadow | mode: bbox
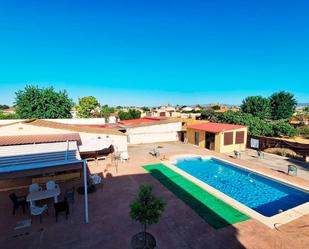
[143,163,250,229]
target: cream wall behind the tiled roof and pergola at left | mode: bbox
[0,123,128,151]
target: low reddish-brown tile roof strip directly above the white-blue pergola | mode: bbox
[0,133,81,146]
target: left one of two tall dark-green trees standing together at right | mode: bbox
[240,96,270,119]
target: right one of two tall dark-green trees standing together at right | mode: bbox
[270,91,297,120]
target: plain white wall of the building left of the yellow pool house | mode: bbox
[127,122,182,144]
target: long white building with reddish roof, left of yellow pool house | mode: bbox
[118,117,182,144]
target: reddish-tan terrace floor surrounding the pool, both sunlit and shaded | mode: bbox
[0,142,309,249]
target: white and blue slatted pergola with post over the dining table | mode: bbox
[0,141,89,223]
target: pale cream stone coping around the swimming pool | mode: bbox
[161,154,309,228]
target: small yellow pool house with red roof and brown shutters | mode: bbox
[187,122,247,153]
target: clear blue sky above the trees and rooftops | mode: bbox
[0,0,309,105]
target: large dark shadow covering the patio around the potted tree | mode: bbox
[0,170,244,249]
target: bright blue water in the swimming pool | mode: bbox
[175,158,309,217]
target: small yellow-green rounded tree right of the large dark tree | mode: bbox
[76,96,100,118]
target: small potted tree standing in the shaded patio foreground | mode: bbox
[130,185,166,249]
